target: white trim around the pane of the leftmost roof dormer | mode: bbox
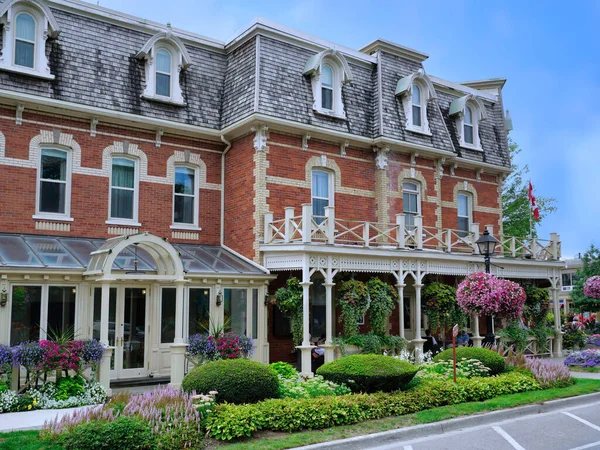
[0,0,60,80]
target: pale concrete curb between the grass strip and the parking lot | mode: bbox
[296,392,600,450]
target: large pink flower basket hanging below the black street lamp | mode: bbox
[456,272,525,319]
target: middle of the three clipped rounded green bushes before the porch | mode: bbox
[317,354,419,392]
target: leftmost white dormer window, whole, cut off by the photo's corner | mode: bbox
[0,0,60,80]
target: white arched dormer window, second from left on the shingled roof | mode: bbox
[137,26,191,106]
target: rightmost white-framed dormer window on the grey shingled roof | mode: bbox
[450,94,487,151]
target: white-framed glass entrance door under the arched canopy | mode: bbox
[94,287,148,378]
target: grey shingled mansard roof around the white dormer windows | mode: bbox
[0,0,509,167]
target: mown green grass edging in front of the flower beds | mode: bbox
[0,378,600,450]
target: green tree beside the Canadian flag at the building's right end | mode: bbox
[502,138,556,239]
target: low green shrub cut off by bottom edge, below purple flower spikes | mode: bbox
[60,416,156,450]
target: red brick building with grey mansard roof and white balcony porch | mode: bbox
[0,0,560,384]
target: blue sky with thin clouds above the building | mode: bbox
[93,0,600,257]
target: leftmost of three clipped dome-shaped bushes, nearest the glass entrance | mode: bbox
[181,358,279,404]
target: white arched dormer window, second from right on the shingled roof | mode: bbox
[396,69,436,136]
